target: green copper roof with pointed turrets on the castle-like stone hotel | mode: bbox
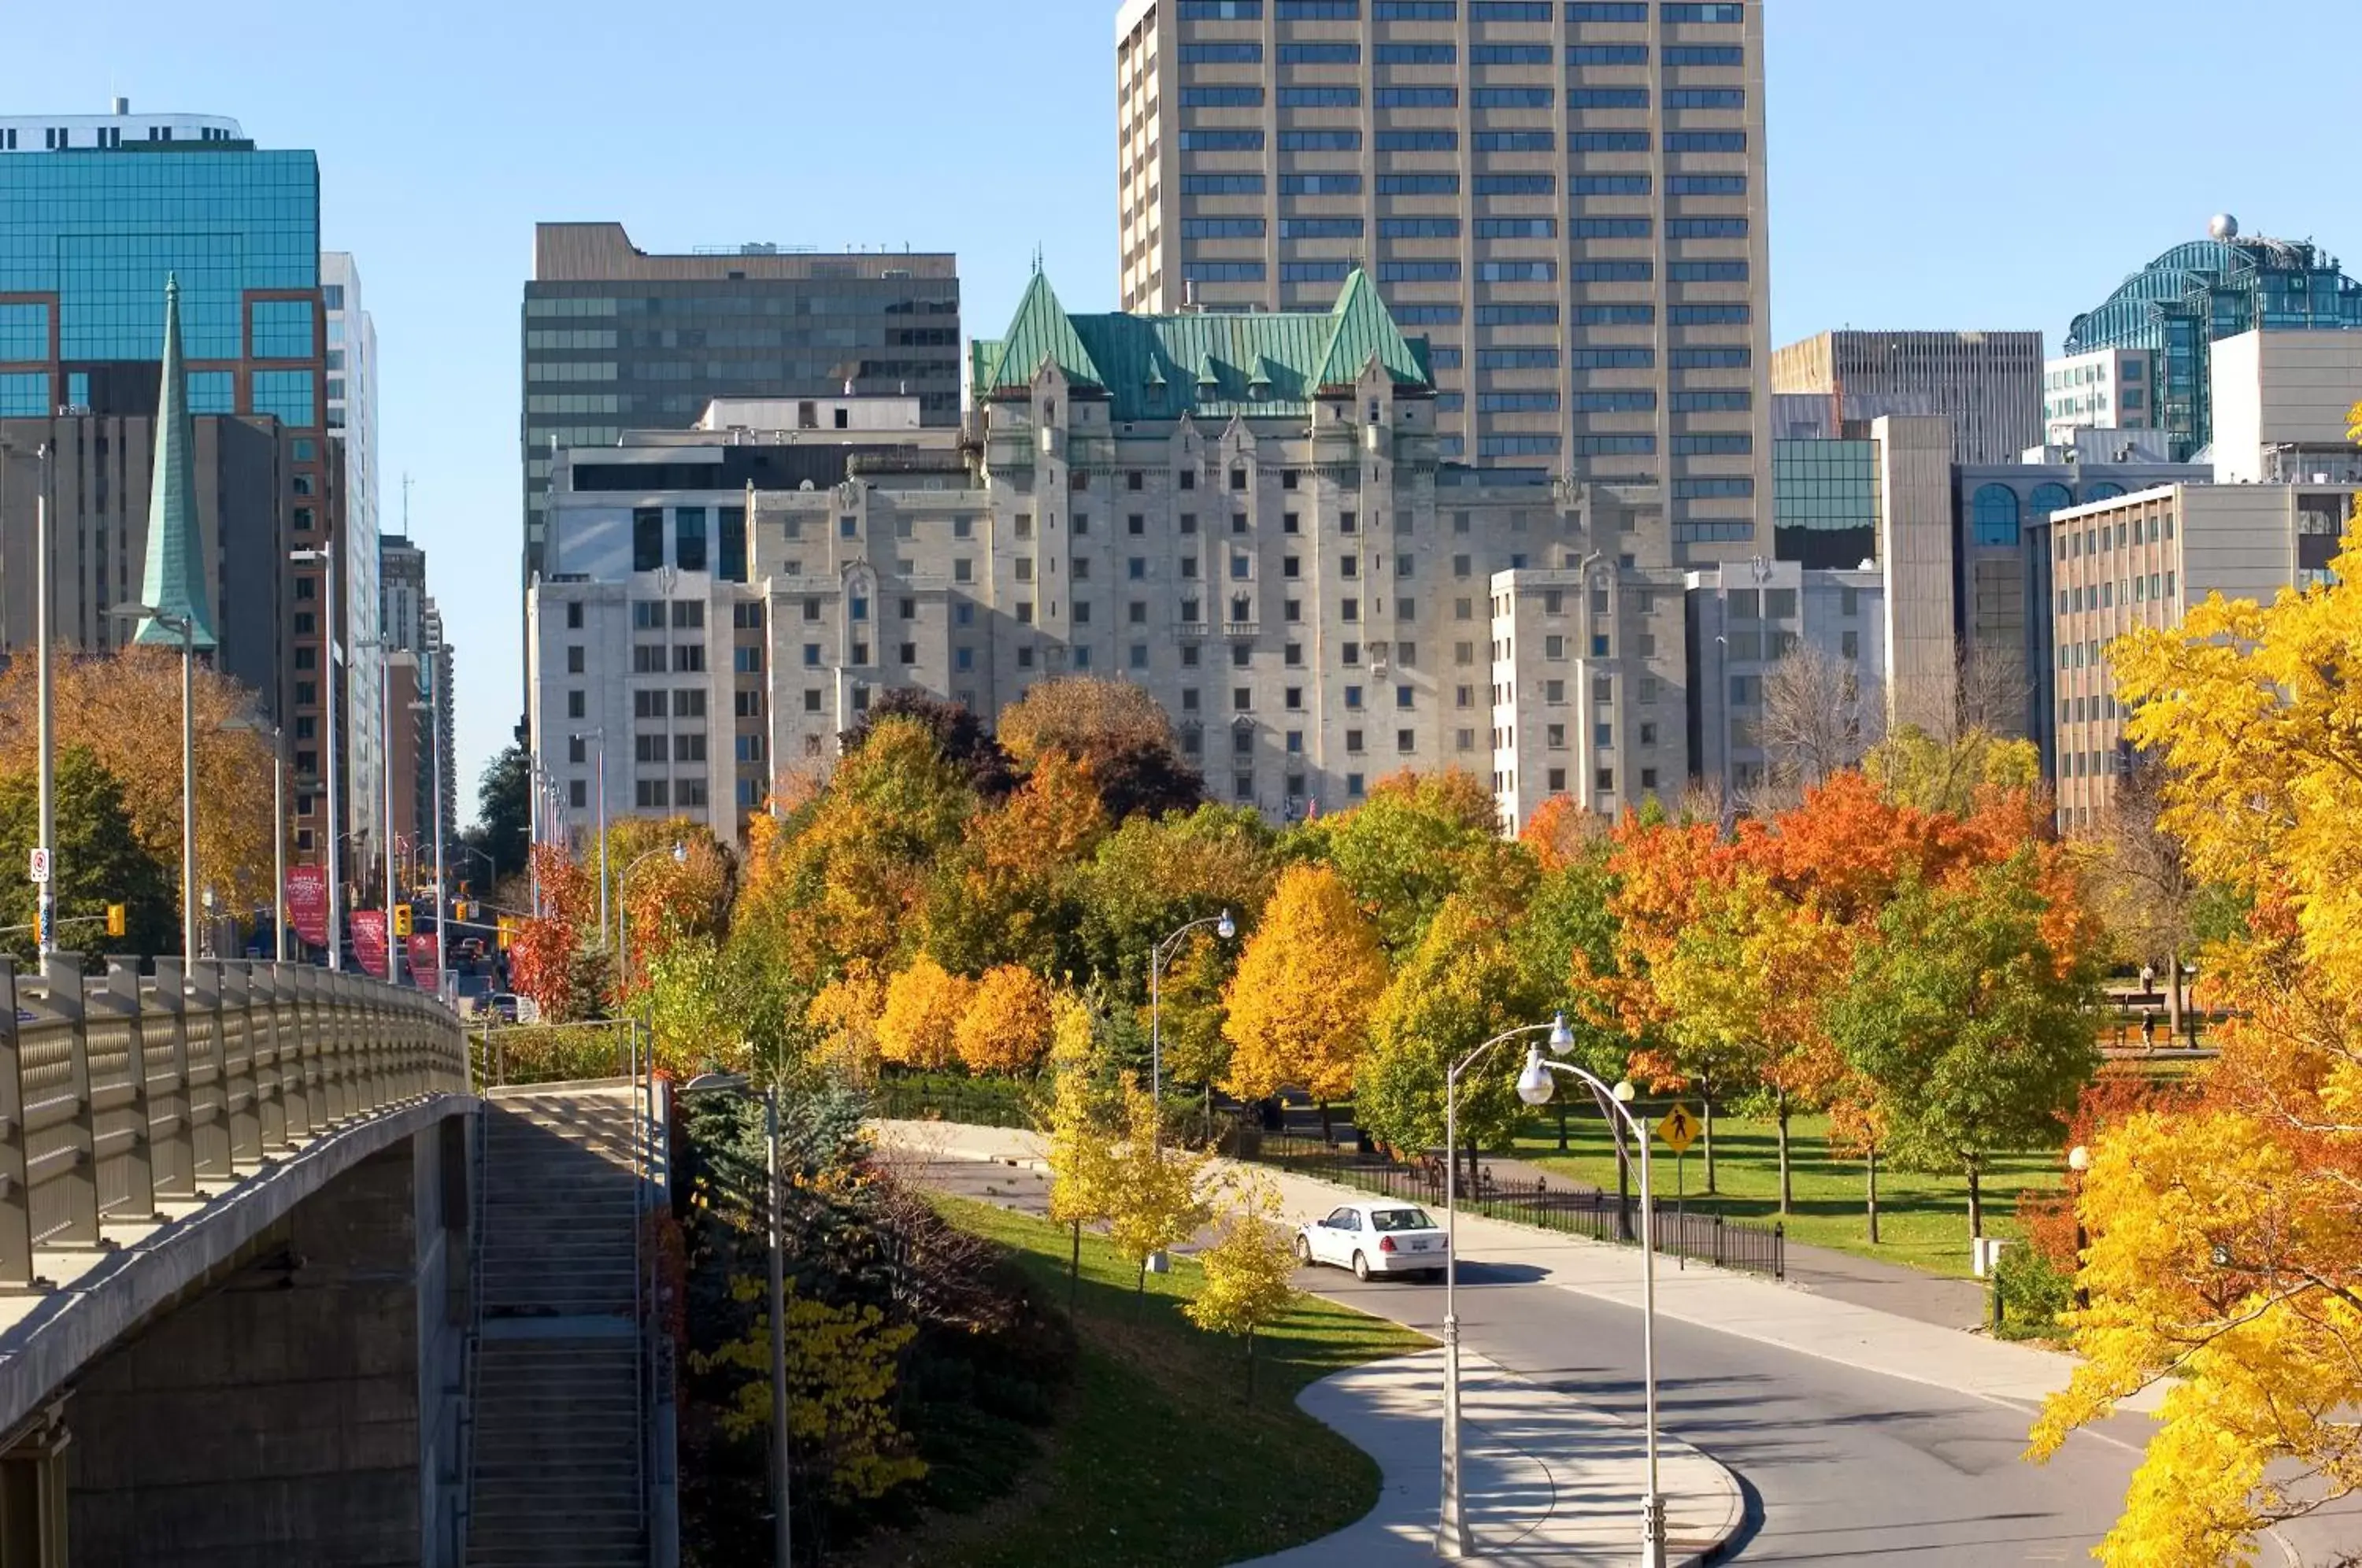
[971,269,1436,420]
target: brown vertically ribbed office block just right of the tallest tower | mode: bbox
[1772,331,2043,463]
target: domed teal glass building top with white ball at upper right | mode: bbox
[2064,239,2362,458]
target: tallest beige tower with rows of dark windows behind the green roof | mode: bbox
[1115,0,1772,564]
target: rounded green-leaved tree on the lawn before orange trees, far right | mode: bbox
[1828,850,2100,1237]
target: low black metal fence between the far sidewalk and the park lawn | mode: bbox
[1224,1129,1788,1280]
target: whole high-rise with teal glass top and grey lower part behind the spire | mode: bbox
[0,99,359,883]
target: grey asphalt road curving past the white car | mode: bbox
[928,1162,2164,1568]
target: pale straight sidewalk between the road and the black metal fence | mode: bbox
[876,1122,2164,1410]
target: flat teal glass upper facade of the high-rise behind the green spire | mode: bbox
[0,142,321,427]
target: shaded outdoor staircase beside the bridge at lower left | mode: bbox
[468,1084,650,1568]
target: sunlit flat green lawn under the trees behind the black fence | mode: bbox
[1516,1100,2064,1278]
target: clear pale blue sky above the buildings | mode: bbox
[0,0,2362,817]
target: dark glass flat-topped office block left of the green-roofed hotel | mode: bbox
[520,222,959,597]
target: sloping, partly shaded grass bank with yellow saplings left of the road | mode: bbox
[862,1197,1429,1568]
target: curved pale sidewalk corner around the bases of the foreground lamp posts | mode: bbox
[1247,1351,1746,1568]
